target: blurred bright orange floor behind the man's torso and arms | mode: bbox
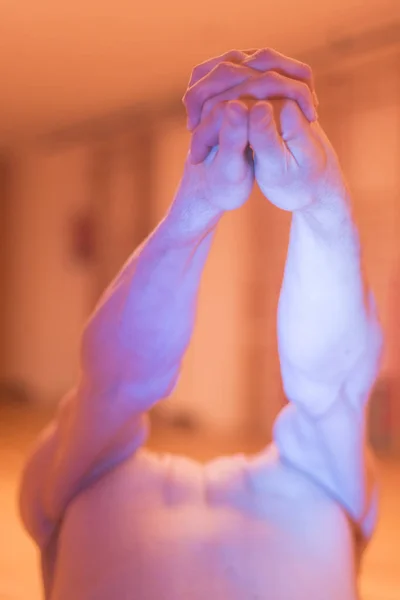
[0,405,400,600]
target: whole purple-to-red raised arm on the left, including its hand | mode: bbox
[21,102,254,547]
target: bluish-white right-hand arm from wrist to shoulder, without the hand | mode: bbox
[275,186,382,536]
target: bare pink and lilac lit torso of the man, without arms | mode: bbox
[46,447,357,600]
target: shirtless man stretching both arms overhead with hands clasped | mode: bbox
[21,50,381,600]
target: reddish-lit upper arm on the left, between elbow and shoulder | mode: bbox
[19,390,147,548]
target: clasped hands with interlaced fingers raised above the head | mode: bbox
[183,49,345,211]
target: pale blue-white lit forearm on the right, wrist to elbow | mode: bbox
[278,192,380,408]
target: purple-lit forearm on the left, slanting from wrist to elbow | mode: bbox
[82,171,221,401]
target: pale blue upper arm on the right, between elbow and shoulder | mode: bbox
[274,398,377,537]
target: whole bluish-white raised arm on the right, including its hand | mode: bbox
[249,101,382,536]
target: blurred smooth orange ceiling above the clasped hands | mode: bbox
[0,0,400,145]
